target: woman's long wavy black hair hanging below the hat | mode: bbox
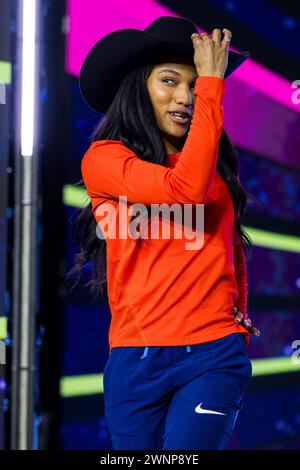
[67,64,256,296]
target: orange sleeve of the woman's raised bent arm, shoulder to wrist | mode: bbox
[81,76,225,205]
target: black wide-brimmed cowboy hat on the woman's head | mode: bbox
[79,16,250,114]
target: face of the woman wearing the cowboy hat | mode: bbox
[147,60,197,153]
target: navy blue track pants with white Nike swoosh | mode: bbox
[103,333,252,450]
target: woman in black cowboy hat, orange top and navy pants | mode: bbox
[72,17,258,450]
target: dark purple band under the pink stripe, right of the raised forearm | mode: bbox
[223,80,300,168]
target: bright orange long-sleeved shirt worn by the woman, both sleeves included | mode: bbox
[81,76,250,350]
